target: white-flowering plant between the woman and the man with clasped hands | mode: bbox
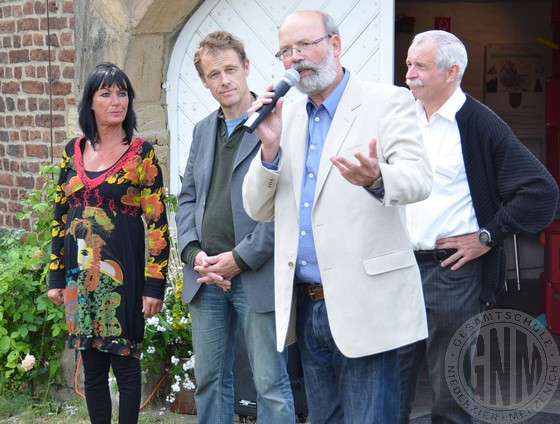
[141,195,194,403]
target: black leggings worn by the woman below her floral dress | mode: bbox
[81,349,142,424]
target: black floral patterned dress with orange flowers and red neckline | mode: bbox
[49,137,169,358]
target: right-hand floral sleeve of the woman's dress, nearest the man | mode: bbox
[140,143,169,299]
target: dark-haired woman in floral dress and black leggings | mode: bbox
[48,63,169,424]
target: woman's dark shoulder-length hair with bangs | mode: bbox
[78,62,136,148]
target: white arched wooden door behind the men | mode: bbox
[166,0,394,193]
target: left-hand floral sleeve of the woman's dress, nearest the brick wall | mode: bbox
[49,148,70,289]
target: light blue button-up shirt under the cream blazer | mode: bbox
[296,70,350,283]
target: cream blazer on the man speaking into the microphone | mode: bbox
[243,75,432,357]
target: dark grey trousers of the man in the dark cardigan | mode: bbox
[398,260,483,424]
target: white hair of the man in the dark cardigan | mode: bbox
[411,30,469,85]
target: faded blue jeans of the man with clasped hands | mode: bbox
[189,277,295,424]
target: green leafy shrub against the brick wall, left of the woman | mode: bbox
[0,165,66,395]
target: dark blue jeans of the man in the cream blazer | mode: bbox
[296,295,399,424]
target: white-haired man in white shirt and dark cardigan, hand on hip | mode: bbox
[399,30,558,424]
